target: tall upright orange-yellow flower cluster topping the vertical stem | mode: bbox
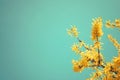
[92,17,103,40]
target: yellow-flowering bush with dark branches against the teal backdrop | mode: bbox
[67,17,120,80]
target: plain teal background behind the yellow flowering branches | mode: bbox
[0,0,120,80]
